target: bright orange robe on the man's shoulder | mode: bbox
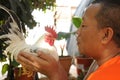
[87,56,120,80]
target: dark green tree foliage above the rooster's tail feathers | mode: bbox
[0,0,56,28]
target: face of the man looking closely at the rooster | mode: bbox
[77,4,101,57]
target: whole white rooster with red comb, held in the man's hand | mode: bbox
[0,5,58,77]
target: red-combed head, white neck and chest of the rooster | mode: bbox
[31,26,58,60]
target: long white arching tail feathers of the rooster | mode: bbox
[0,5,27,58]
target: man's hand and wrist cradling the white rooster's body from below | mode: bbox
[17,52,67,80]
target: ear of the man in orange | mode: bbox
[102,27,113,44]
